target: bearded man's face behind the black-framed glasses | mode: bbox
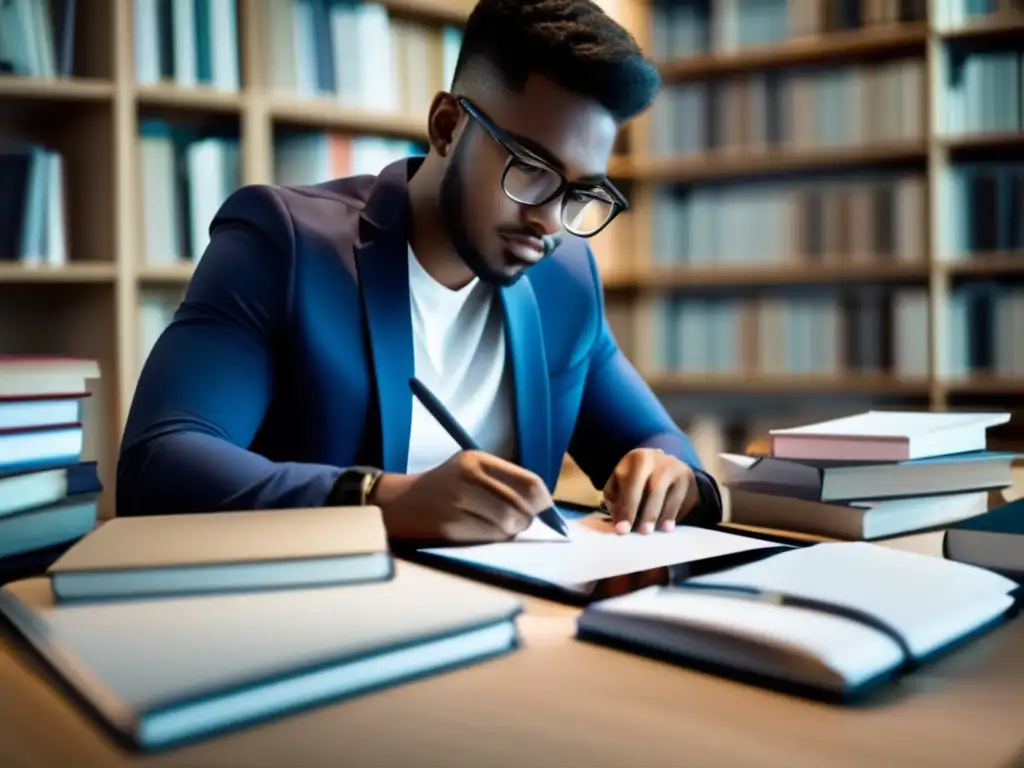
[440,76,617,285]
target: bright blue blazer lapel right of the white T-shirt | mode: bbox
[501,278,555,489]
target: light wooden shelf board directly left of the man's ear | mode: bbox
[267,97,427,140]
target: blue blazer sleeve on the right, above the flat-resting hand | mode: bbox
[569,249,722,525]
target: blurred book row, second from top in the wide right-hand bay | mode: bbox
[649,57,927,157]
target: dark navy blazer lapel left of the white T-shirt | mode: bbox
[355,161,415,472]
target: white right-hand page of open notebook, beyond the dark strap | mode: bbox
[692,542,1017,655]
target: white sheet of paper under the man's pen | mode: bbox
[426,513,777,584]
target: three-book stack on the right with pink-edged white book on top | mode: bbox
[721,411,1016,541]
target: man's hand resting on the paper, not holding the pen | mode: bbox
[604,449,700,534]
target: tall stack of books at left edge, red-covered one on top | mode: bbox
[0,356,102,565]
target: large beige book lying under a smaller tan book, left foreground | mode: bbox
[0,563,521,751]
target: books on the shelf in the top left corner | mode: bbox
[0,0,80,78]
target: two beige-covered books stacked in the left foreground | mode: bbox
[0,507,521,751]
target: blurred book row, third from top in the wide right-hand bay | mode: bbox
[651,172,928,268]
